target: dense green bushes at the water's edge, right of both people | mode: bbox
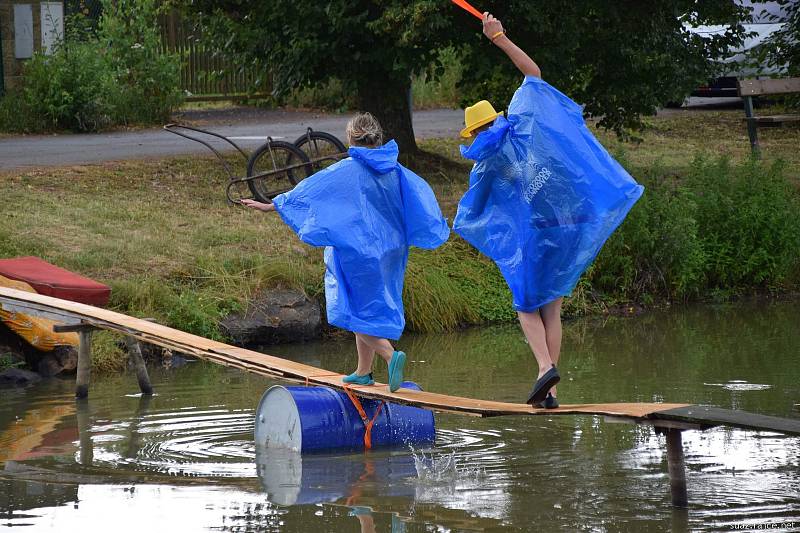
[587,158,800,301]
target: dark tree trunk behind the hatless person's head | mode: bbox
[357,73,417,153]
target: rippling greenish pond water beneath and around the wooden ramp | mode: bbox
[0,302,800,532]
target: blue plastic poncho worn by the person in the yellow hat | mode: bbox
[453,76,643,311]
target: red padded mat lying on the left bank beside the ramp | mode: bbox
[0,257,111,307]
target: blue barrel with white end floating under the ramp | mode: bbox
[255,381,436,453]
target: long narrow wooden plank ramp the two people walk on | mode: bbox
[0,287,800,435]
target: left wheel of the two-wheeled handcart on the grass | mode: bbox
[247,140,314,203]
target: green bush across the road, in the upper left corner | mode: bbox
[0,0,182,132]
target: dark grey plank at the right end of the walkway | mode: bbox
[651,405,800,435]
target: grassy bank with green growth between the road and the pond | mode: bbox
[0,111,800,369]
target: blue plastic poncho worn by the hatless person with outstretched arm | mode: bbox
[274,141,450,339]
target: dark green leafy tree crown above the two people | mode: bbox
[183,0,746,151]
